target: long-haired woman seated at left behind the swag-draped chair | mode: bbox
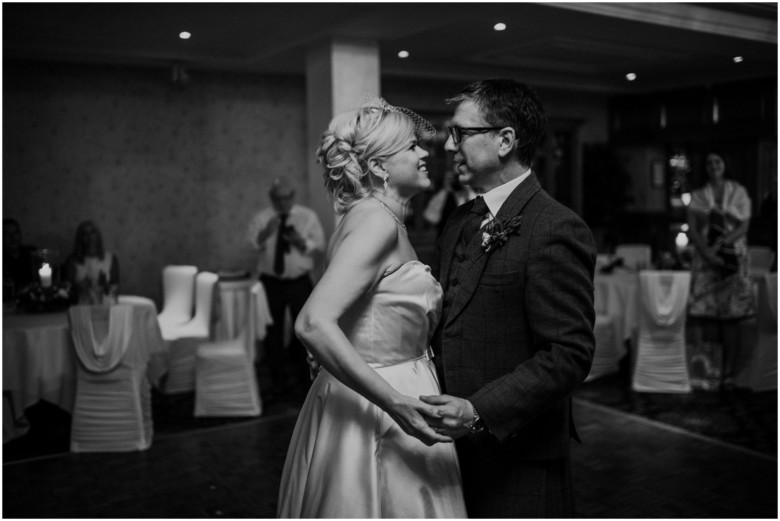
[67,221,119,304]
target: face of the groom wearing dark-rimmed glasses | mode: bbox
[444,100,500,191]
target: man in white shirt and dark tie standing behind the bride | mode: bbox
[246,177,325,397]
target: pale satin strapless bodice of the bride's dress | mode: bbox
[339,260,442,366]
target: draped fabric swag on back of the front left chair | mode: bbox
[69,305,133,373]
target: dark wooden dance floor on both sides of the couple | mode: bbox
[2,400,778,518]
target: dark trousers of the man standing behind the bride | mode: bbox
[260,275,313,391]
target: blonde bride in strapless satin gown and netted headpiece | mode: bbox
[277,99,466,518]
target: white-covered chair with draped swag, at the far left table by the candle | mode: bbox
[68,305,153,452]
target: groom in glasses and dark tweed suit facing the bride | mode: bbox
[421,79,596,518]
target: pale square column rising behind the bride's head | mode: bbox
[304,39,380,242]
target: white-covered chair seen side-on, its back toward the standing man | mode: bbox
[162,271,218,394]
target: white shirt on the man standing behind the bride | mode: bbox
[246,204,325,279]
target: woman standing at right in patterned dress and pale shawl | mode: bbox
[688,152,755,387]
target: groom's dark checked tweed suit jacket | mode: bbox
[433,174,596,459]
